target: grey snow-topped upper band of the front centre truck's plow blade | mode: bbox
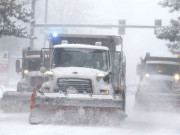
[35,93,123,109]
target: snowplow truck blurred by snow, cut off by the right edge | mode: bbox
[135,55,180,110]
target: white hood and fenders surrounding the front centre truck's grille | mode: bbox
[43,67,113,94]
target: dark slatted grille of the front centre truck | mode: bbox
[57,78,92,93]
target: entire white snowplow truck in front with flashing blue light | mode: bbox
[29,34,126,124]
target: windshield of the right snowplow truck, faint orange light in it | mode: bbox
[146,64,179,76]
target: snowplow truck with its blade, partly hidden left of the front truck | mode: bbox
[1,50,46,112]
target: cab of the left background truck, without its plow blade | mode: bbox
[16,50,43,92]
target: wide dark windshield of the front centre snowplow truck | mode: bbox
[52,48,108,71]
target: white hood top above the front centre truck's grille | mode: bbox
[52,67,106,80]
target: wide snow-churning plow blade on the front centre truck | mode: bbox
[29,93,127,125]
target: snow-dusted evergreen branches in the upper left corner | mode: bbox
[0,0,31,37]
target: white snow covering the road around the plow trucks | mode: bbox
[0,85,180,135]
